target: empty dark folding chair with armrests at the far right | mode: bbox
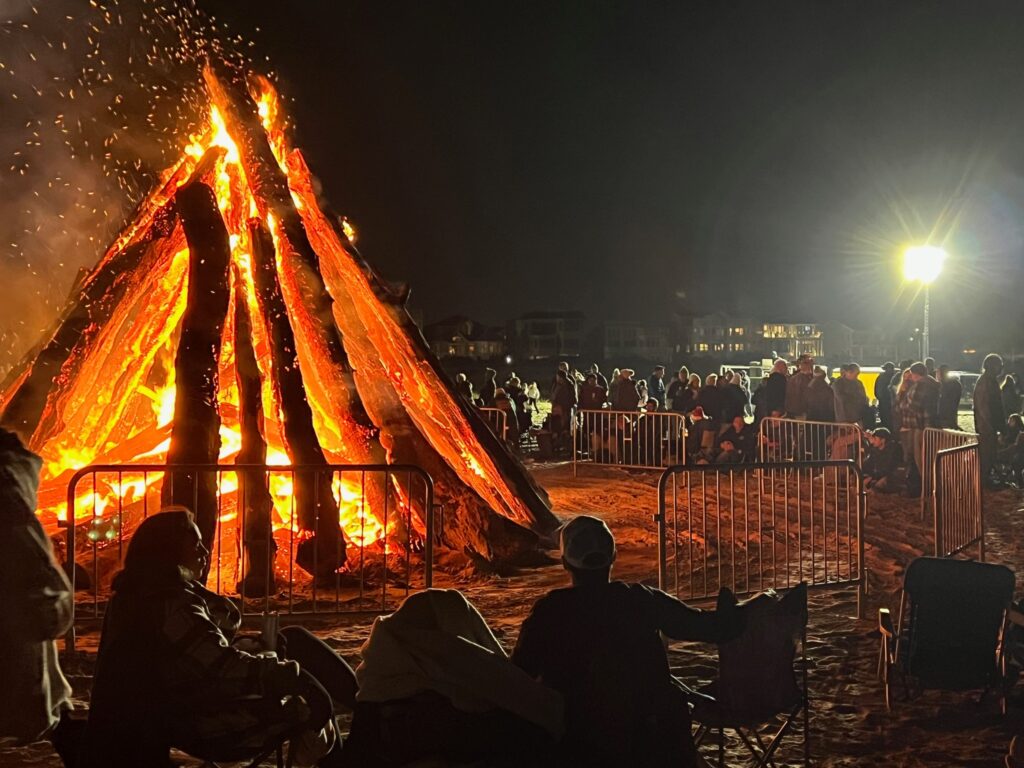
[879,557,1015,714]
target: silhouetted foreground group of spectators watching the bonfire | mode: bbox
[0,430,744,768]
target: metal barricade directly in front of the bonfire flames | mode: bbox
[60,464,435,650]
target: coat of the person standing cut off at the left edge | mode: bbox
[0,444,73,741]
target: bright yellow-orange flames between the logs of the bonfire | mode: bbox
[33,82,392,546]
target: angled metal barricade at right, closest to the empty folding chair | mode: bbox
[933,442,985,561]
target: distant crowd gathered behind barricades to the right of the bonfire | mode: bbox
[457,354,1024,487]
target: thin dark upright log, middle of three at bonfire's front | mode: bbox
[234,268,278,597]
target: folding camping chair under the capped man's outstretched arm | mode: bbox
[693,583,810,768]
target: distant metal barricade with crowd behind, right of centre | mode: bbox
[758,416,864,467]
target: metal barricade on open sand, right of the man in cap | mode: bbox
[655,461,866,617]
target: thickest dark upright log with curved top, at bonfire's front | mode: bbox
[163,182,231,550]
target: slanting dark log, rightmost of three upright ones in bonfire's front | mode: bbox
[249,219,345,577]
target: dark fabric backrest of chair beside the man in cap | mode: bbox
[716,584,807,724]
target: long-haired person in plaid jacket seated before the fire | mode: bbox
[82,507,354,768]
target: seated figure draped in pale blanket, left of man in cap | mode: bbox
[344,590,562,768]
